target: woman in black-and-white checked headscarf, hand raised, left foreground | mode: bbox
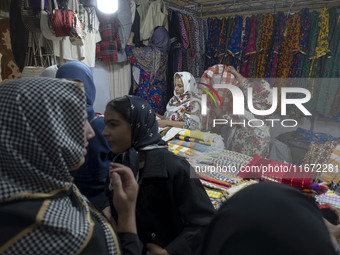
[0,77,138,255]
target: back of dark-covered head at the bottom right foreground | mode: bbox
[201,183,335,255]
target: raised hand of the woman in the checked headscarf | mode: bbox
[109,163,138,233]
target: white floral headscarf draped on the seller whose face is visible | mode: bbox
[165,72,200,123]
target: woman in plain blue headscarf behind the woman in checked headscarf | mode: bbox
[56,61,111,210]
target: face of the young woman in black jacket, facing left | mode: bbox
[103,107,131,154]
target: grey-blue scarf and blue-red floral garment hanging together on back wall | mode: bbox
[125,26,170,114]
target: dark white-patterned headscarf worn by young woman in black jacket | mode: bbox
[115,96,168,177]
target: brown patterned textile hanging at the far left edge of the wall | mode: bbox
[0,19,20,80]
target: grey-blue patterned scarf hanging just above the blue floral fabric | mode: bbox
[133,27,170,83]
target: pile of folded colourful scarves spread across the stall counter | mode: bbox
[168,130,334,208]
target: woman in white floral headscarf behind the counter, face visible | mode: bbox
[157,72,201,130]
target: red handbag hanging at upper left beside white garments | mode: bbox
[50,0,73,37]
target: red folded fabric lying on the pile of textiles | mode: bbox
[240,156,314,189]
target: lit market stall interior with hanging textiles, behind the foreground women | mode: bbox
[0,0,340,253]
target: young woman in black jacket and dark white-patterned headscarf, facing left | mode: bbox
[103,96,214,255]
